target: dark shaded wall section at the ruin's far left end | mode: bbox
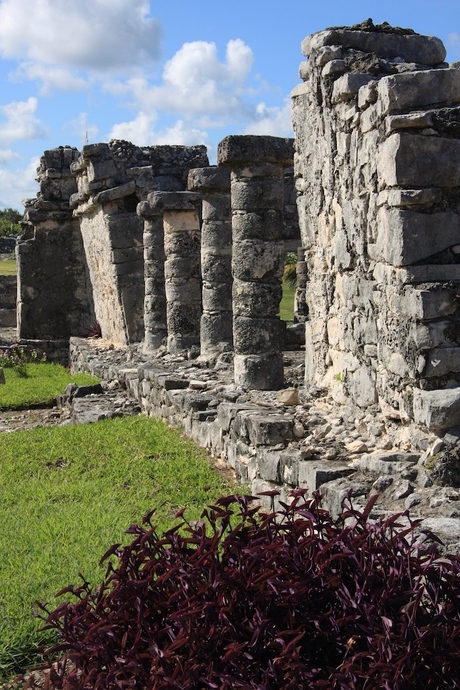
[16,147,94,338]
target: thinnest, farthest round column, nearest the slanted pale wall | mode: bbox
[137,201,168,353]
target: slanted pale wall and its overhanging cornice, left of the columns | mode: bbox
[70,141,208,346]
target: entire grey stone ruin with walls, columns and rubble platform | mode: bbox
[10,20,460,541]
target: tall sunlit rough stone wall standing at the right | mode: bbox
[292,20,460,429]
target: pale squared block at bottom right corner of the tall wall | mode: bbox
[413,387,460,431]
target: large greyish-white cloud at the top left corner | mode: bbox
[0,0,162,70]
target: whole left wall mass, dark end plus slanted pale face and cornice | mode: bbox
[18,140,209,345]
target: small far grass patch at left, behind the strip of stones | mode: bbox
[0,363,97,410]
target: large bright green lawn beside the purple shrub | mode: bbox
[0,416,236,678]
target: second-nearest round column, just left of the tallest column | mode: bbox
[188,167,233,357]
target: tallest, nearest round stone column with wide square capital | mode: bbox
[218,136,294,390]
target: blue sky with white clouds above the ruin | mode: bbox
[0,0,460,210]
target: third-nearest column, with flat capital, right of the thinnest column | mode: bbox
[148,192,201,353]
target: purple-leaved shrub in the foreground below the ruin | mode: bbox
[35,491,460,690]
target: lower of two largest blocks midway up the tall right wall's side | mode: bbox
[369,207,460,266]
